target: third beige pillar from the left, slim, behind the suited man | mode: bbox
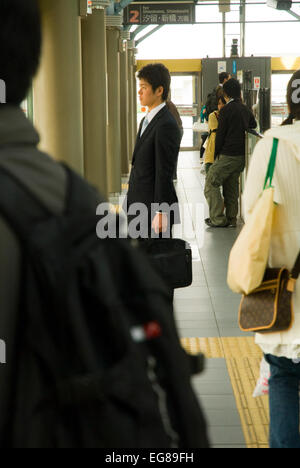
[105,15,124,193]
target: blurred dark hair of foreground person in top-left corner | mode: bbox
[0,0,41,105]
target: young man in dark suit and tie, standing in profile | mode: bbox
[127,64,181,238]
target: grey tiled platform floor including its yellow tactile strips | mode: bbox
[174,152,268,448]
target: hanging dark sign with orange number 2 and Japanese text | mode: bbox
[124,2,196,25]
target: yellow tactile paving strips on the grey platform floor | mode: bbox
[181,337,269,448]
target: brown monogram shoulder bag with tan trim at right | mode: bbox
[239,253,300,333]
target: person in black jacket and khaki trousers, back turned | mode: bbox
[204,78,257,227]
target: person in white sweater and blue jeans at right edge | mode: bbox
[227,70,300,448]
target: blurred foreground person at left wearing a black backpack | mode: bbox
[0,0,208,448]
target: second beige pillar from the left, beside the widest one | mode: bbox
[81,0,109,196]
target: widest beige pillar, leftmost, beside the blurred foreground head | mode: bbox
[33,0,83,174]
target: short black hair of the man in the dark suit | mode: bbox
[138,63,171,101]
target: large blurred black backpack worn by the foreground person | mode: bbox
[0,168,208,448]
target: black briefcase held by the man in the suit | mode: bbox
[139,239,193,289]
